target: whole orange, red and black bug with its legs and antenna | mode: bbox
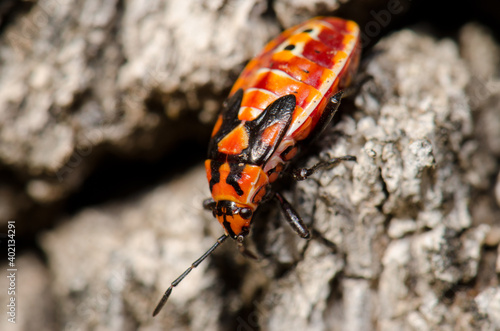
[153,17,360,316]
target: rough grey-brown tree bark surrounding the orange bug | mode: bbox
[0,0,500,330]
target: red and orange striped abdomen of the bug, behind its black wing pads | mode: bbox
[230,17,360,141]
